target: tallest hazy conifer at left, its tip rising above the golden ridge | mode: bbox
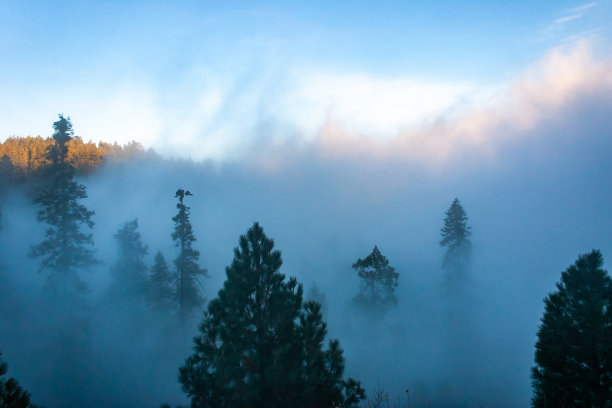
[30,114,97,292]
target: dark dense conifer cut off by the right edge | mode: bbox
[531,250,612,408]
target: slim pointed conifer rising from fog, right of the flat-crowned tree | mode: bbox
[440,198,472,286]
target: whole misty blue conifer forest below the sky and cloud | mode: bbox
[0,114,612,408]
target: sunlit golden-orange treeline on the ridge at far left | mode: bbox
[0,136,158,185]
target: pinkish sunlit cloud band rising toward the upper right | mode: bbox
[308,42,612,165]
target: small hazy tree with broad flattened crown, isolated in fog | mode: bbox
[353,246,399,313]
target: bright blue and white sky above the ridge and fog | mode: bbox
[0,0,612,162]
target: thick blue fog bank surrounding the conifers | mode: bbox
[0,77,612,408]
